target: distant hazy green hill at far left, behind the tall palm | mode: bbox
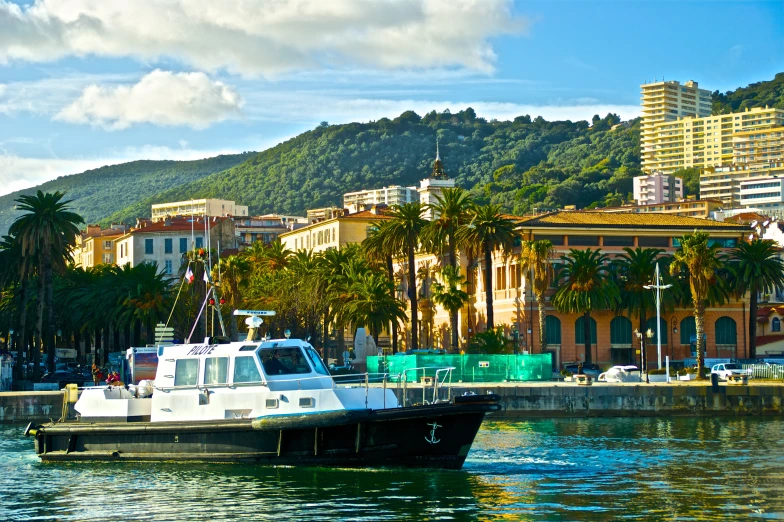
[0,152,256,233]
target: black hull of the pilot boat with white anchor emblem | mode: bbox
[31,396,498,469]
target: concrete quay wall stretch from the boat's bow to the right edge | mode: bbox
[397,383,784,418]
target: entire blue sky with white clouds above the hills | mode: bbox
[0,0,784,194]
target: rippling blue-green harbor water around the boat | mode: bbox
[0,417,784,521]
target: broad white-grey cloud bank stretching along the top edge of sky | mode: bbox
[0,0,527,76]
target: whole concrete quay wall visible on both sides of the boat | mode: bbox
[0,381,784,423]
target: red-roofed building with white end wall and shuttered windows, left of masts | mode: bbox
[115,217,237,276]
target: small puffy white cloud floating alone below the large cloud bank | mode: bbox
[55,70,243,130]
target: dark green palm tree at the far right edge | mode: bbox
[730,238,784,359]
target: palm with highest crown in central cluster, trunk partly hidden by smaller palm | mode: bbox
[422,187,474,351]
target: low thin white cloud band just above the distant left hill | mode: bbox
[0,145,248,195]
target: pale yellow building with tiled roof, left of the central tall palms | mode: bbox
[278,205,388,252]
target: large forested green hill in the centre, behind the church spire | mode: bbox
[104,109,640,220]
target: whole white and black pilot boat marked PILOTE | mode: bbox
[25,316,499,469]
